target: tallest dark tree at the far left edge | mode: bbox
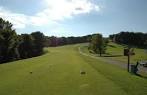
[0,18,19,63]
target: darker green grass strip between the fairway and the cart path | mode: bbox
[78,44,147,95]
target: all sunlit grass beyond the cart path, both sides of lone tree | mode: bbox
[81,42,147,64]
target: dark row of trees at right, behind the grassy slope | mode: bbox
[109,31,147,48]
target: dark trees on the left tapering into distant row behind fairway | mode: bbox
[0,18,92,64]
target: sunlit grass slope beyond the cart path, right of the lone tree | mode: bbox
[106,42,147,64]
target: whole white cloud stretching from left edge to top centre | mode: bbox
[0,0,100,28]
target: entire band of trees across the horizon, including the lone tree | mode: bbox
[4,18,147,63]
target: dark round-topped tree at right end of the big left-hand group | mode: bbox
[31,31,45,56]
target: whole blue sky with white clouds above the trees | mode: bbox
[0,0,147,37]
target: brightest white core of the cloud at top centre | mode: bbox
[42,0,100,20]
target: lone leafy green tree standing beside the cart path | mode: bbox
[89,34,106,56]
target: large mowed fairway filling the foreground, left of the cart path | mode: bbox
[0,45,147,95]
